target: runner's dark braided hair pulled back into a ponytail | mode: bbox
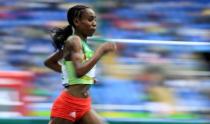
[51,5,89,50]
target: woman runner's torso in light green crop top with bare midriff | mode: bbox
[62,36,94,98]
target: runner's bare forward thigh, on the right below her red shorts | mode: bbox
[80,110,107,124]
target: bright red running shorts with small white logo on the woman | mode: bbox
[51,91,91,122]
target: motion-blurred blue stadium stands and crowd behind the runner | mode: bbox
[0,0,210,124]
